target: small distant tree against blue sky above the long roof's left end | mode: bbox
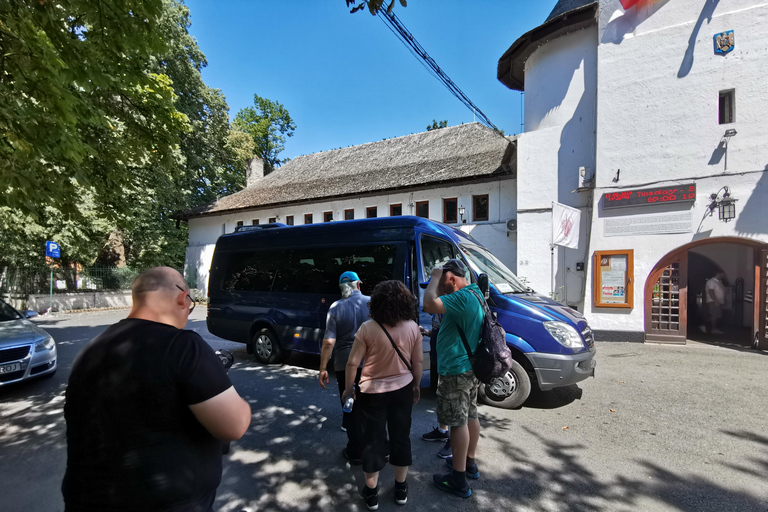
[234,94,296,174]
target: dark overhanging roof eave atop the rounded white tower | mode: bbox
[496,0,600,91]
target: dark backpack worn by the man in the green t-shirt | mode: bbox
[456,290,512,384]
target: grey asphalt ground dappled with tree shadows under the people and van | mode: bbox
[0,308,768,512]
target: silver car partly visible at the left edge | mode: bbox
[0,299,56,386]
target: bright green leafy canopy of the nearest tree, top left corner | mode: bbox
[0,0,187,219]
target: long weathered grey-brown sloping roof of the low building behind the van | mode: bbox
[177,123,516,219]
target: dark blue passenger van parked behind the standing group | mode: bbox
[207,216,595,408]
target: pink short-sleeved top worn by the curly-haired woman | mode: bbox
[355,320,422,393]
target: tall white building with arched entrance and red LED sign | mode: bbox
[498,0,768,344]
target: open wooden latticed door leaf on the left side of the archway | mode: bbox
[645,251,688,344]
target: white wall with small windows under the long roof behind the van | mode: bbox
[185,179,517,294]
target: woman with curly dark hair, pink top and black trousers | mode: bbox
[342,281,423,510]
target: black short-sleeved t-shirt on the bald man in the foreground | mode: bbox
[62,318,232,512]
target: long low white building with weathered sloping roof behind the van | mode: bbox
[180,123,517,294]
